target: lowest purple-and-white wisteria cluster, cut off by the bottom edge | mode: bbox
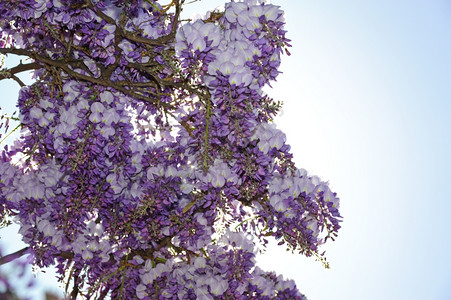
[133,231,306,300]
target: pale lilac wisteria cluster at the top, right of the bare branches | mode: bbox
[175,1,288,89]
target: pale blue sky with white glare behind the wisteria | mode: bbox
[0,0,451,300]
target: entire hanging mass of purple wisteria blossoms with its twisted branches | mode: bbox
[0,0,341,299]
